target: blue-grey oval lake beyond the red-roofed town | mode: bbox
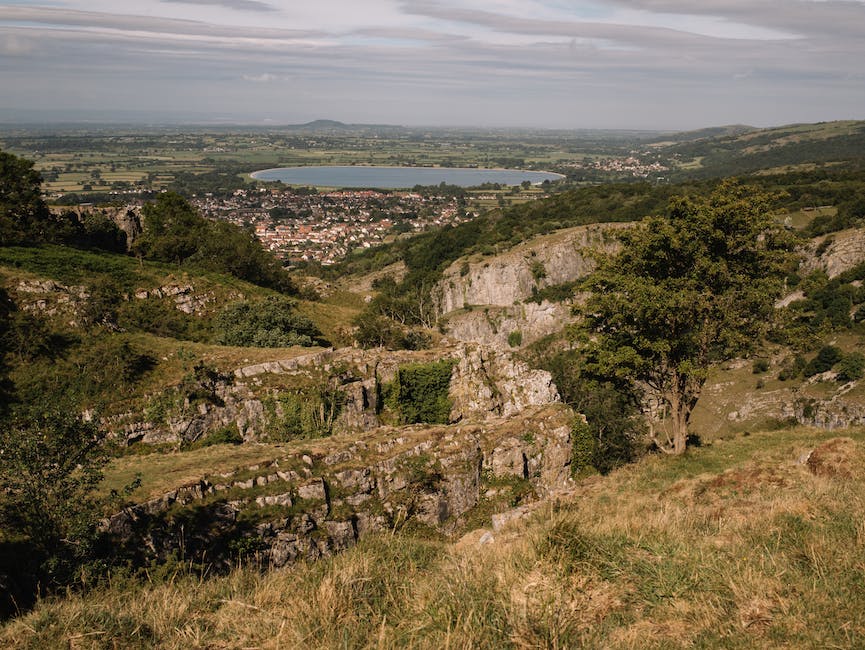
[250,166,564,190]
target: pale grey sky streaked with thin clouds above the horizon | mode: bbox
[0,0,865,130]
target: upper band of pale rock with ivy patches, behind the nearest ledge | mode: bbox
[113,344,559,443]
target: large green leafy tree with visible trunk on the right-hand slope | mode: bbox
[582,182,790,454]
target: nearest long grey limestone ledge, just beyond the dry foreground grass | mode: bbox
[103,404,574,567]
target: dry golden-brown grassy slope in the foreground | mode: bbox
[0,422,865,648]
